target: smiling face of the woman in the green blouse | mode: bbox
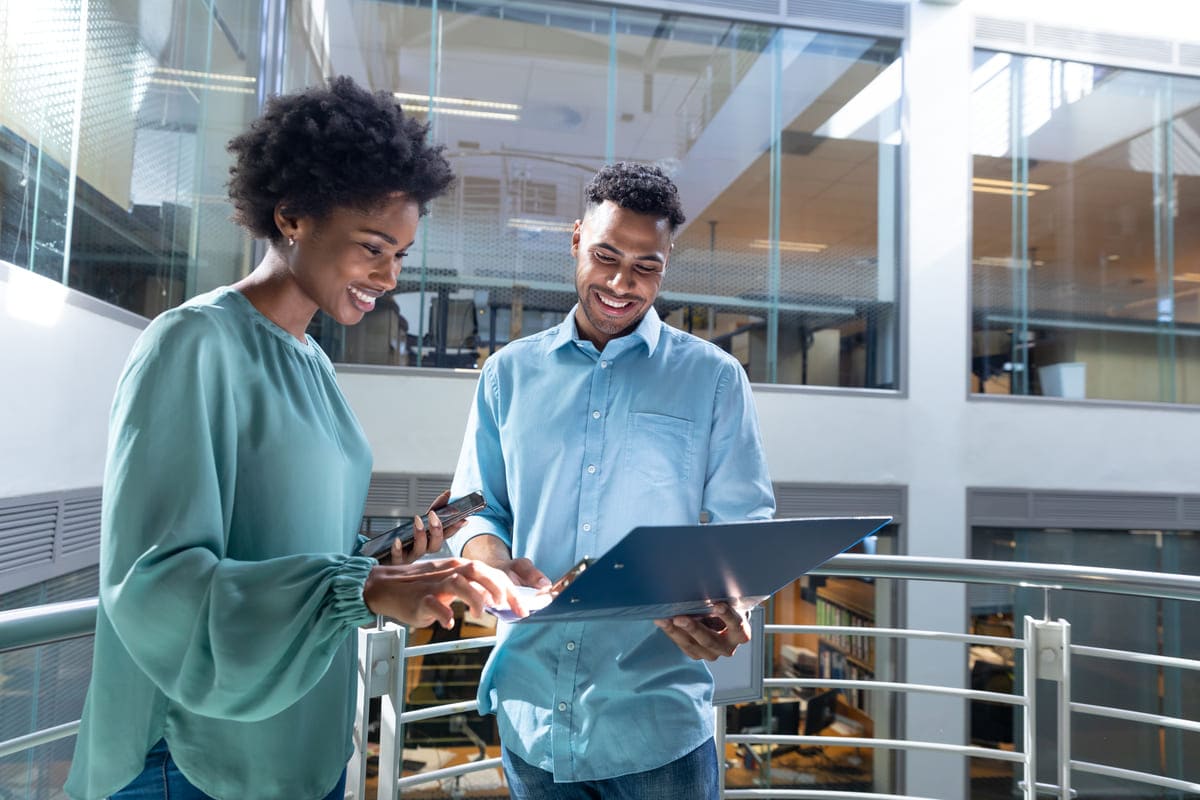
[280,193,420,325]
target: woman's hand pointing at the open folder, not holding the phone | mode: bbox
[362,559,528,628]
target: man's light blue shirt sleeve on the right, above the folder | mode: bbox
[703,360,775,522]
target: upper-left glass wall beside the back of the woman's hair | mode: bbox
[0,0,260,317]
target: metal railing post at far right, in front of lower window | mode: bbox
[1024,616,1075,800]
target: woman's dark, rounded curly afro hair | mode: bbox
[227,76,454,242]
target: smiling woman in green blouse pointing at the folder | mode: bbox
[66,78,520,800]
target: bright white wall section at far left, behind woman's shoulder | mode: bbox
[0,261,146,499]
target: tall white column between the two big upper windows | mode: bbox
[900,2,972,800]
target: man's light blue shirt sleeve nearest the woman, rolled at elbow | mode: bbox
[449,363,512,555]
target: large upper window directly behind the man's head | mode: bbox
[307,0,900,387]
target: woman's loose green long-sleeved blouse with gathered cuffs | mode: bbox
[66,288,376,800]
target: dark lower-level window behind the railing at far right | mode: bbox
[968,528,1200,798]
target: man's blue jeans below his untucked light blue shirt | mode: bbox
[503,739,721,800]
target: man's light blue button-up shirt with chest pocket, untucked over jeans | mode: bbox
[450,309,775,781]
